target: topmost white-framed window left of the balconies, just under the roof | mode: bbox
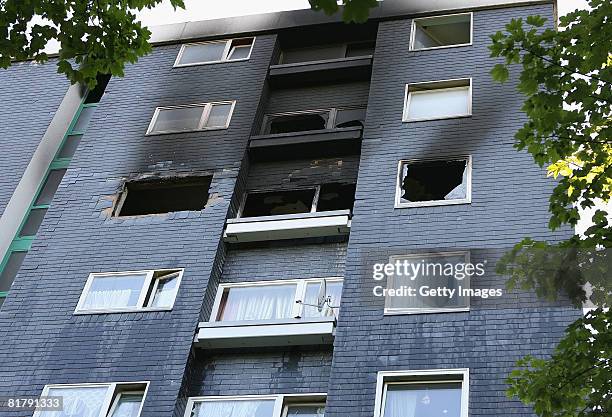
[174,38,255,67]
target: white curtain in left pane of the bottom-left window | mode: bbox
[39,387,109,417]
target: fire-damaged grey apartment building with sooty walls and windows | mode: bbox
[0,0,580,417]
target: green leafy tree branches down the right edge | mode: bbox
[490,0,612,417]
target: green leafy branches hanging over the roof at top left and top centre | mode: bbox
[0,0,377,88]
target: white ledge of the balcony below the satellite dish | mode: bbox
[194,317,336,349]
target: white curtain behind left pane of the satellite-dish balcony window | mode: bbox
[221,285,296,321]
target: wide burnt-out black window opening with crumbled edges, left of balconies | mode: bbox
[116,177,211,216]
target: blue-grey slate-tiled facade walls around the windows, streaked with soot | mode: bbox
[0,2,580,417]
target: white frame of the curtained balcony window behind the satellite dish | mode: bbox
[208,276,344,323]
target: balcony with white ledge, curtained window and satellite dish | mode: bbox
[194,277,342,349]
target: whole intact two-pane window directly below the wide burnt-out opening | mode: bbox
[76,269,183,313]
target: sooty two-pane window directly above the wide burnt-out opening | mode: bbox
[147,101,235,135]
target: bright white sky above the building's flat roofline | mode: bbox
[139,0,587,26]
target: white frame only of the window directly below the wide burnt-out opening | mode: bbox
[74,268,185,314]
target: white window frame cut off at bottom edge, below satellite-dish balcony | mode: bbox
[184,393,327,417]
